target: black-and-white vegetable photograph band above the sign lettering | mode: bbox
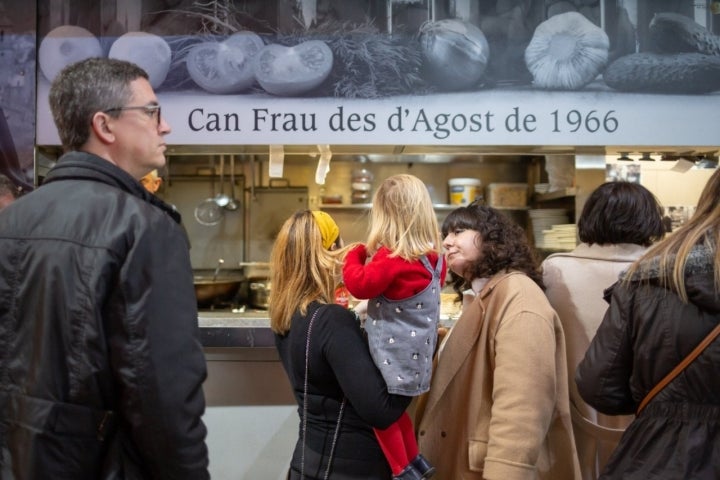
[38,0,720,99]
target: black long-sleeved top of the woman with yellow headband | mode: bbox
[275,303,411,480]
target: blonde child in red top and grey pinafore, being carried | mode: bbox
[343,174,446,480]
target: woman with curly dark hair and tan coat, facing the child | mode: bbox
[415,203,580,480]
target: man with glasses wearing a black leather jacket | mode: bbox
[0,58,209,480]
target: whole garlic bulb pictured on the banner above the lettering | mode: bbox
[525,12,610,90]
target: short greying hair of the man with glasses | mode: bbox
[49,58,148,150]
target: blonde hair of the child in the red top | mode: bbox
[366,174,441,261]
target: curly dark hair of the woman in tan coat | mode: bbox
[442,203,545,294]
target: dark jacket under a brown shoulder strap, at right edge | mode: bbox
[575,246,720,480]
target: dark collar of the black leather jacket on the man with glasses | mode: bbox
[43,152,182,223]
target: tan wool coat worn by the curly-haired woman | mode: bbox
[415,272,580,480]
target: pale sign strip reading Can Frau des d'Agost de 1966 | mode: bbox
[38,82,720,146]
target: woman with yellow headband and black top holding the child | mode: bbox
[269,210,410,480]
